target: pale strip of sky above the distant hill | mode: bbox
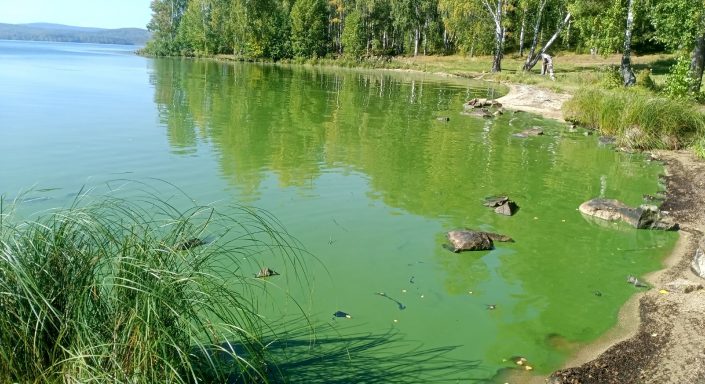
[0,0,152,28]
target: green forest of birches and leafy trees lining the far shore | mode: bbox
[145,0,705,93]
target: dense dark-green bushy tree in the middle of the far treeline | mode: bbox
[290,0,329,57]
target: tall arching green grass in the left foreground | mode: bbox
[0,197,302,383]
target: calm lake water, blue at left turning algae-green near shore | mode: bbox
[0,41,676,383]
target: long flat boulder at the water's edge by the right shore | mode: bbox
[579,198,678,231]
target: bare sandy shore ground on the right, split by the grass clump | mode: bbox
[498,85,705,384]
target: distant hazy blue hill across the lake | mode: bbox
[0,23,151,45]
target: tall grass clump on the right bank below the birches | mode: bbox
[563,88,705,149]
